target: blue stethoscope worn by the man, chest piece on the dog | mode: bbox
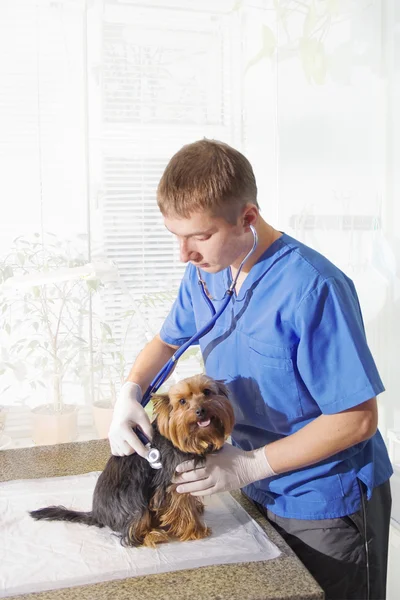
[134,225,258,469]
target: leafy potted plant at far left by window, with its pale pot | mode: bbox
[0,234,97,444]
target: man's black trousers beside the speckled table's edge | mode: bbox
[254,481,392,600]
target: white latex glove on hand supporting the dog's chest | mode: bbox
[173,444,276,496]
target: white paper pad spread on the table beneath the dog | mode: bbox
[0,473,280,598]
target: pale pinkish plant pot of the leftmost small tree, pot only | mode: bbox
[31,404,78,446]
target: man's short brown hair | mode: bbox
[157,139,258,222]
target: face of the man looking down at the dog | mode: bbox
[164,212,249,273]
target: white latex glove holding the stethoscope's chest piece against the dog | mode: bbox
[108,381,153,458]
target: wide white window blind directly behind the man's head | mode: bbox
[88,2,242,376]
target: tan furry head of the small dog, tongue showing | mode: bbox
[153,375,234,454]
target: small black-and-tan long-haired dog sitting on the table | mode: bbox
[29,375,234,548]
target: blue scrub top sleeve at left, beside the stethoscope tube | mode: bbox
[160,264,196,346]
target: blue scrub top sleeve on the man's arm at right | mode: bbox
[295,278,385,414]
